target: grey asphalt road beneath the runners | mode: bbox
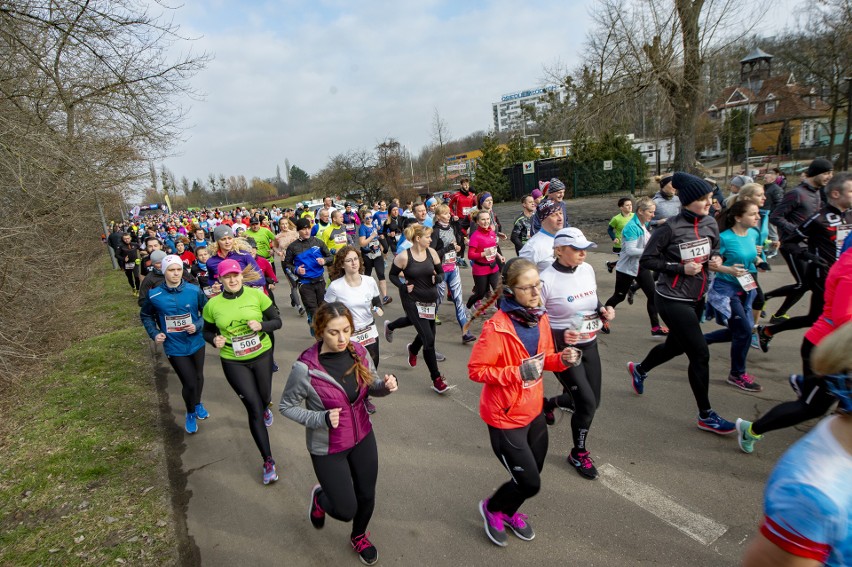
[160,232,812,567]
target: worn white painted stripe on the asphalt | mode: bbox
[598,463,728,545]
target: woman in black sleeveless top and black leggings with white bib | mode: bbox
[385,223,451,394]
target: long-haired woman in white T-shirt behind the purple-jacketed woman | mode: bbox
[325,246,384,414]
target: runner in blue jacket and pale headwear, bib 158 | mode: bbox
[139,255,210,433]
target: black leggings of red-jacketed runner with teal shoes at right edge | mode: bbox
[751,339,837,435]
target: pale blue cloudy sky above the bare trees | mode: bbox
[164,0,798,180]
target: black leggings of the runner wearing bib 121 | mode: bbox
[640,294,712,412]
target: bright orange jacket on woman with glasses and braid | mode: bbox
[467,310,567,429]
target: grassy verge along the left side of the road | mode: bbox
[0,270,179,565]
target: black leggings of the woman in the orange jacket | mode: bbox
[488,414,548,516]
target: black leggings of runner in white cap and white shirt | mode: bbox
[553,338,601,451]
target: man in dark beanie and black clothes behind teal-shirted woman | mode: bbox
[764,158,834,324]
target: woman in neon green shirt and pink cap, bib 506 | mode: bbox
[203,260,281,484]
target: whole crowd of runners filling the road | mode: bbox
[107,163,852,565]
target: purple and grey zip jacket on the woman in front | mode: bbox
[278,343,388,455]
